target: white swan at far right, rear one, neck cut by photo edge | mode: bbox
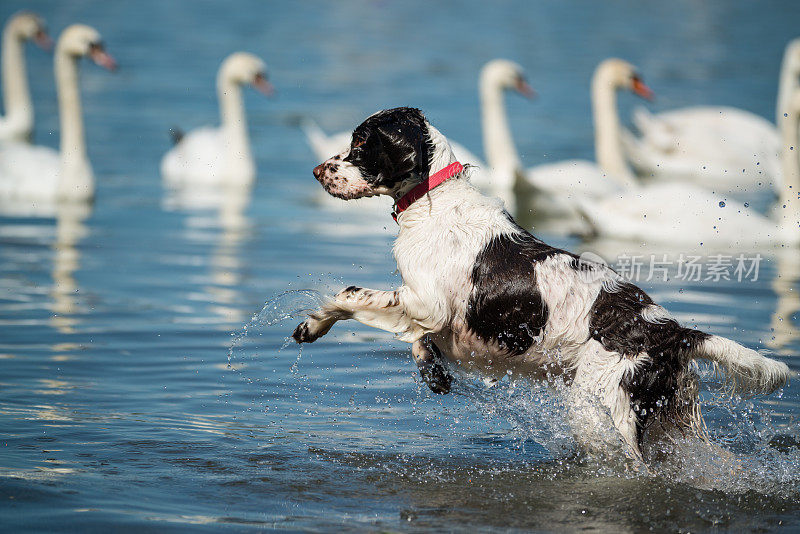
[624,39,800,194]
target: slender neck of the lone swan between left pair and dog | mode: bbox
[217,74,252,181]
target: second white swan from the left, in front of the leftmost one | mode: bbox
[0,24,116,209]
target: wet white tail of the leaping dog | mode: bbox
[693,336,793,394]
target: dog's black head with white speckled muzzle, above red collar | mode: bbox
[314,108,438,200]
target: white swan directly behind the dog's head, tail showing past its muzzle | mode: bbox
[301,59,534,211]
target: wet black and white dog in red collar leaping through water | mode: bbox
[293,108,790,458]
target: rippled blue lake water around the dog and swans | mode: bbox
[0,0,800,531]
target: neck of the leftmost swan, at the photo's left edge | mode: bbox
[0,26,33,137]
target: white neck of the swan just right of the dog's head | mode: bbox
[480,76,522,187]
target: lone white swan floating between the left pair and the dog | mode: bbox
[161,52,273,187]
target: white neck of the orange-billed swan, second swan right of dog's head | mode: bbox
[592,71,636,188]
